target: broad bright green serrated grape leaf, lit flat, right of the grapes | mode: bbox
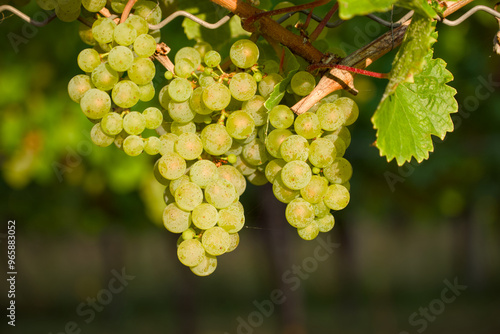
[372,50,458,166]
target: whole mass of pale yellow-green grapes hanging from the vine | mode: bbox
[62,0,358,276]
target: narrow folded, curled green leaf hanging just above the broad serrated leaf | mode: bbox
[382,14,437,96]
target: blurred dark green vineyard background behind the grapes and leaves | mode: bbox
[0,0,500,334]
